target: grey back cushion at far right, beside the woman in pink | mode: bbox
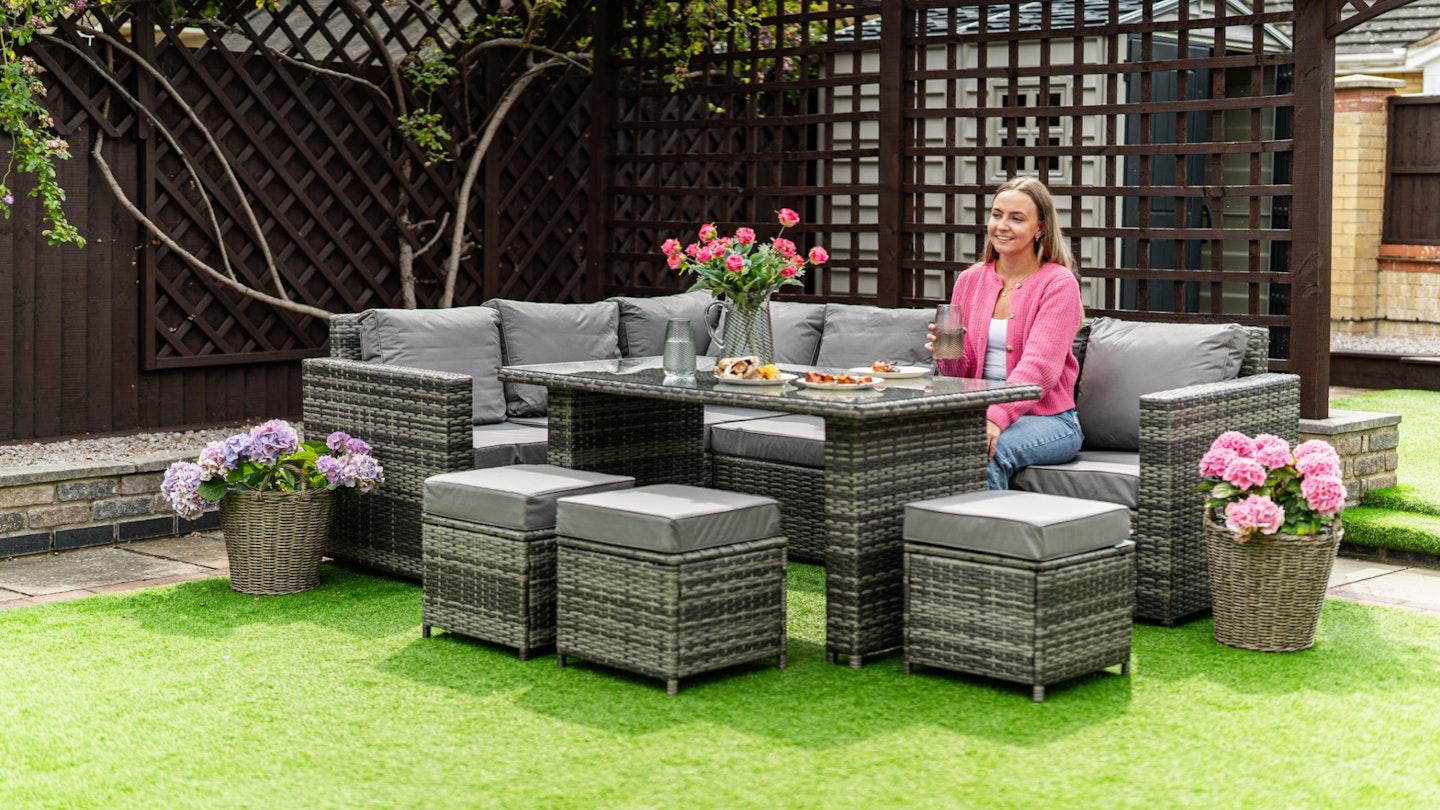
[1076,317,1247,450]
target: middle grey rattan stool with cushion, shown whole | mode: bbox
[554,484,785,695]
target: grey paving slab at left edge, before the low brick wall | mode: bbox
[0,546,212,597]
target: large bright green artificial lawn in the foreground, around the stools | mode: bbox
[0,565,1440,809]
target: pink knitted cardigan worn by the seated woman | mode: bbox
[937,262,1083,430]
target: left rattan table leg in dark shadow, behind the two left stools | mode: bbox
[549,388,707,486]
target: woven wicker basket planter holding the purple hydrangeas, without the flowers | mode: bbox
[220,490,336,595]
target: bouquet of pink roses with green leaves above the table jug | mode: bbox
[660,208,829,308]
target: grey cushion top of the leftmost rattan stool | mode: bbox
[425,464,635,532]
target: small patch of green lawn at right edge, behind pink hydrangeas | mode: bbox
[1331,389,1440,555]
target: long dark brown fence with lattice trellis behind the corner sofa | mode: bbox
[0,0,1365,441]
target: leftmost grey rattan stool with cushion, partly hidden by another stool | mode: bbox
[420,464,635,660]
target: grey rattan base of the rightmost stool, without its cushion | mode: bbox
[904,542,1135,702]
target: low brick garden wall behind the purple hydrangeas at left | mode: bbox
[0,453,220,558]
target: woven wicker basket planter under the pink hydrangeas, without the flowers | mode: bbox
[1205,510,1344,653]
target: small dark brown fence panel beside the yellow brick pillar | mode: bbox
[1385,95,1440,245]
